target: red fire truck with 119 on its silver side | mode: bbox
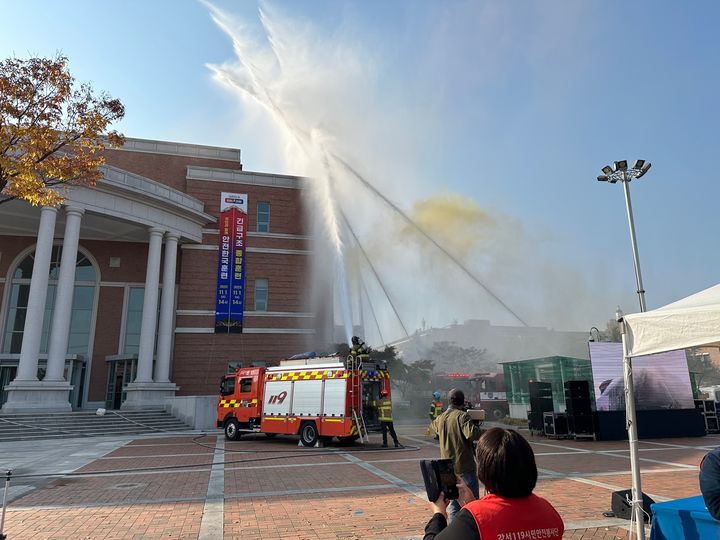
[217,355,390,446]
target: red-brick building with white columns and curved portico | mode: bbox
[0,139,332,412]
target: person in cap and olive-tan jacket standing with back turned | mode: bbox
[432,388,482,520]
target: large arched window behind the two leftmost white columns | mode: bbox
[2,246,98,354]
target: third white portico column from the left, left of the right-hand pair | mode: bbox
[134,227,165,383]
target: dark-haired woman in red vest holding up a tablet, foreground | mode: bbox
[423,428,565,540]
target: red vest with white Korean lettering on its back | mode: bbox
[463,494,565,540]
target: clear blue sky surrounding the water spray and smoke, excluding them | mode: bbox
[0,0,720,336]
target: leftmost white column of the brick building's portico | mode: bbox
[15,206,57,382]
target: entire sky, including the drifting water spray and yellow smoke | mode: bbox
[0,0,720,339]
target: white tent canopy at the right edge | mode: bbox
[623,285,720,357]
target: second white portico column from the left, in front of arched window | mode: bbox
[45,207,85,381]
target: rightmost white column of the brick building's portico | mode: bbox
[155,233,180,383]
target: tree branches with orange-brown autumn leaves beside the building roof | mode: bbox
[0,55,125,206]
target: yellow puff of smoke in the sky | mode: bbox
[402,193,495,258]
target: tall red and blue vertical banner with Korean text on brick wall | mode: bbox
[215,192,247,334]
